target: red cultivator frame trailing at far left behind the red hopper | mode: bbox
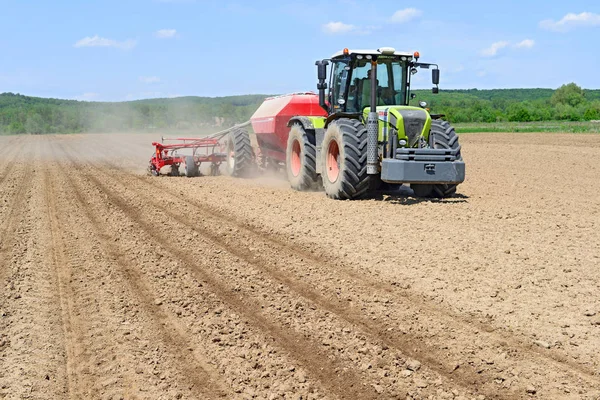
[149,137,227,176]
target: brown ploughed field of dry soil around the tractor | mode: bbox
[0,134,600,399]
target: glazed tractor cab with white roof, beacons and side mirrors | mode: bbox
[317,47,439,114]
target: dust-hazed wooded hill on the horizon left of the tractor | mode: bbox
[0,93,269,133]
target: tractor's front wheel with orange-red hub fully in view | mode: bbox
[321,118,371,200]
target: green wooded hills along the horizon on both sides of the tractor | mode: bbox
[0,84,600,133]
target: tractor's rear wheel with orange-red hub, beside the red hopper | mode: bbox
[285,124,317,191]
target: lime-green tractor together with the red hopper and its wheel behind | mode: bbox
[227,47,465,199]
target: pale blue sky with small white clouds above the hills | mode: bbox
[0,0,600,101]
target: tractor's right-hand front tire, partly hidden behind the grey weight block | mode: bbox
[410,119,462,198]
